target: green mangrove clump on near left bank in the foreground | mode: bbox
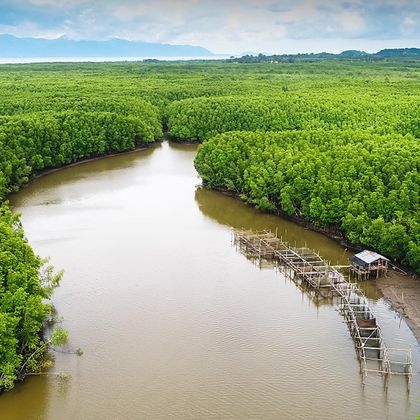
[0,207,51,390]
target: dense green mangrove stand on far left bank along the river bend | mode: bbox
[0,111,162,195]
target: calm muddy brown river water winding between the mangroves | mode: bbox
[0,142,420,420]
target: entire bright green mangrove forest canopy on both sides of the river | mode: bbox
[0,60,420,391]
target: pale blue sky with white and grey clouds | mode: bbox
[0,0,420,54]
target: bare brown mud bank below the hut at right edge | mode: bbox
[376,269,420,342]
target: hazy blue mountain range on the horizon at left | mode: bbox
[0,35,213,58]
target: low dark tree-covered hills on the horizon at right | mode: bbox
[228,48,420,63]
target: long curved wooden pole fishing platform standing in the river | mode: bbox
[233,230,412,386]
